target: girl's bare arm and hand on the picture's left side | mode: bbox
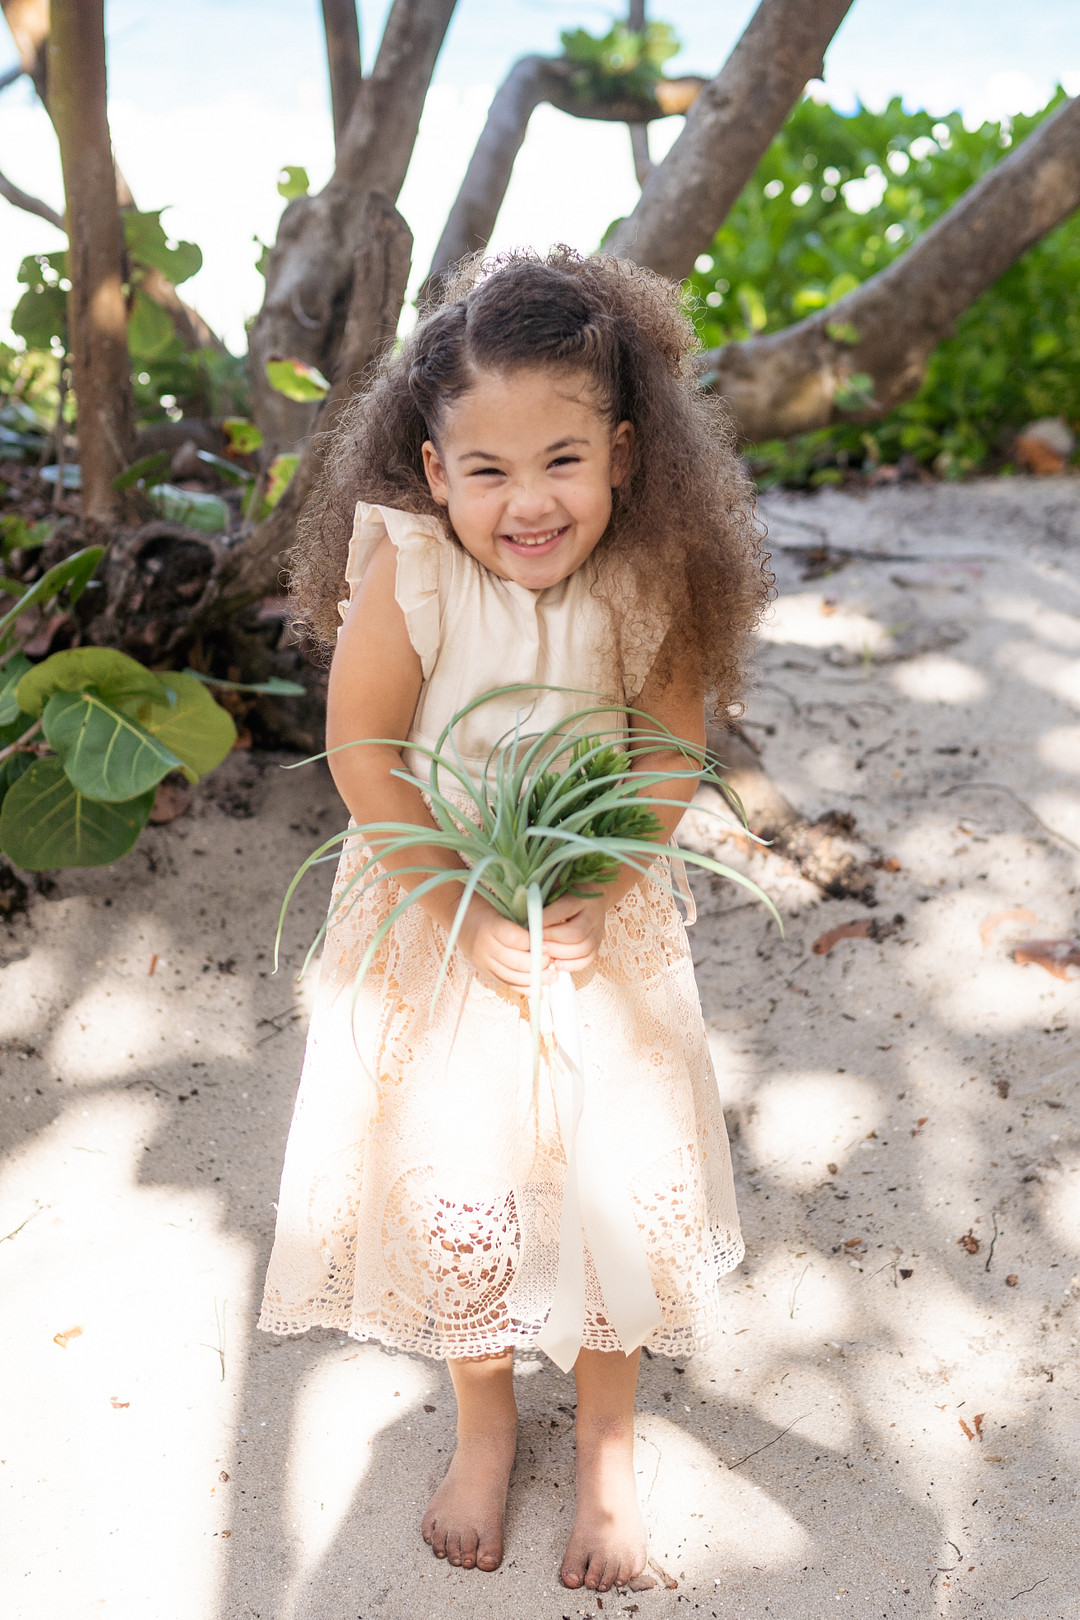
[327,539,529,988]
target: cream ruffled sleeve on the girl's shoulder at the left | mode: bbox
[337,501,452,680]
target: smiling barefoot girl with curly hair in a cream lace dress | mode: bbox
[261,249,769,1592]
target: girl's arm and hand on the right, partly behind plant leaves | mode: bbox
[544,644,704,974]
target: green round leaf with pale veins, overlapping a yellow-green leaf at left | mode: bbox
[44,692,183,804]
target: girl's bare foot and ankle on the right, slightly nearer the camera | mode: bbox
[560,1418,656,1592]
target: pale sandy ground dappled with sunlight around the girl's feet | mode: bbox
[0,480,1080,1620]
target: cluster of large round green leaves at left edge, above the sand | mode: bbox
[0,576,236,872]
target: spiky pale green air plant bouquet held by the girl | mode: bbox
[277,685,782,1056]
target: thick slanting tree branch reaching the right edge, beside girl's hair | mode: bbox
[704,97,1080,442]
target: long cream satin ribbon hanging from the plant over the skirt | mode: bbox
[536,972,664,1372]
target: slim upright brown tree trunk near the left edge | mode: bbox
[49,0,131,523]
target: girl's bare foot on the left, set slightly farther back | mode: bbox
[421,1422,517,1570]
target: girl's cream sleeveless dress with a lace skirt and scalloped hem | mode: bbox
[259,504,743,1358]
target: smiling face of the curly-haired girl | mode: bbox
[424,366,633,591]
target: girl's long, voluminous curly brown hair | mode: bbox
[290,248,772,716]
